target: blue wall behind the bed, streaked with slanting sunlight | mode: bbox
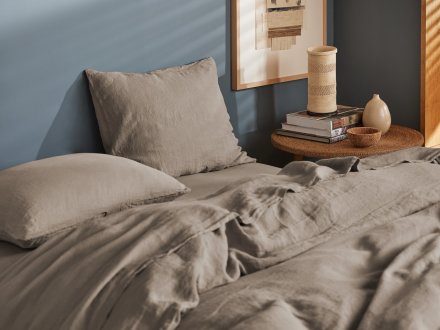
[0,0,333,169]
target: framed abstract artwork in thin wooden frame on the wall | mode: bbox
[231,0,327,90]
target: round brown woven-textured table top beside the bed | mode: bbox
[272,125,425,158]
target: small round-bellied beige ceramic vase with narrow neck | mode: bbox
[362,94,391,135]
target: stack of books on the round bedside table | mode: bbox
[277,106,364,143]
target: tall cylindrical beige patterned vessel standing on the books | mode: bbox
[307,46,338,115]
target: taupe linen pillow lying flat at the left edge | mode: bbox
[0,154,189,248]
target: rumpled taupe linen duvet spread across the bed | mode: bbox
[0,148,440,329]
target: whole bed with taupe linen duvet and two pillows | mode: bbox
[0,59,440,329]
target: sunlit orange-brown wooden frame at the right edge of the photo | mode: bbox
[420,0,440,147]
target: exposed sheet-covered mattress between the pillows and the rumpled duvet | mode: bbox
[0,163,280,268]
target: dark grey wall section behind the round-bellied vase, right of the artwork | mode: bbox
[334,0,420,129]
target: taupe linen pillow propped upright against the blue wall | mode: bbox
[86,58,255,177]
